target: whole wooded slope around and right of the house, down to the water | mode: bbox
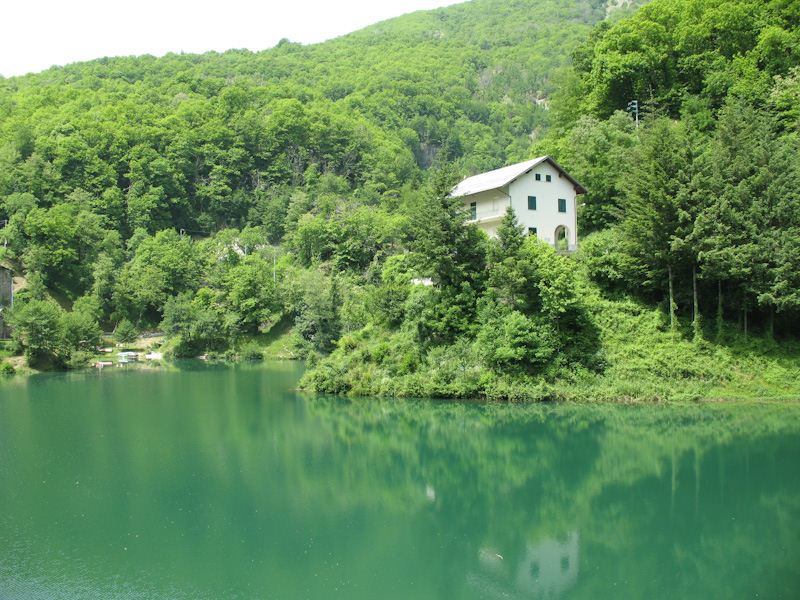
[307,0,800,399]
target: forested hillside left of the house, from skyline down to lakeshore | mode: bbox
[0,0,636,364]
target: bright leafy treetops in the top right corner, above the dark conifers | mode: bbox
[575,0,800,117]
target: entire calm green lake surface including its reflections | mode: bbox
[0,363,800,600]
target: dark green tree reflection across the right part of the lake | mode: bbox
[302,399,800,598]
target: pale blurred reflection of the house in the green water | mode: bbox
[468,531,579,600]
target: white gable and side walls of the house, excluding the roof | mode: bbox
[463,161,578,250]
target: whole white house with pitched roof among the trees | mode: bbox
[450,156,586,251]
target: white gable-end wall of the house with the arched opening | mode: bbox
[508,162,578,250]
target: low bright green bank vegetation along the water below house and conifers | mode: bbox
[301,284,800,402]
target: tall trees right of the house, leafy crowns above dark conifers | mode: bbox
[542,0,800,333]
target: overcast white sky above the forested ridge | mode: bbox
[0,0,458,77]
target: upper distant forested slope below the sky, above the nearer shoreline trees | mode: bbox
[0,0,620,238]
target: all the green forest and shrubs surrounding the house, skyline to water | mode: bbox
[0,0,800,399]
